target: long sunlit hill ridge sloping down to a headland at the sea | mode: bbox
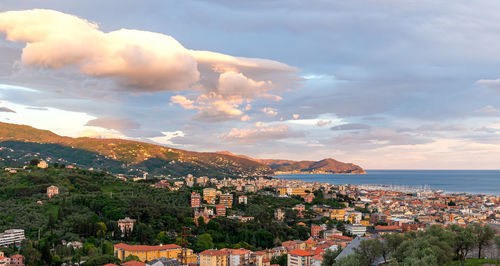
[0,122,364,177]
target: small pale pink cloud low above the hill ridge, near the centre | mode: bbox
[221,122,304,144]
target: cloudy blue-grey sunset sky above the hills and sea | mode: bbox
[0,0,500,169]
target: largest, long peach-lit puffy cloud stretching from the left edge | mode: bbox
[0,9,299,121]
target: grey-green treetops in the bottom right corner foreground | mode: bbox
[327,224,499,266]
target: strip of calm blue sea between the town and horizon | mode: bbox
[275,170,500,195]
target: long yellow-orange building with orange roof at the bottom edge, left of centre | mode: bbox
[114,243,198,263]
